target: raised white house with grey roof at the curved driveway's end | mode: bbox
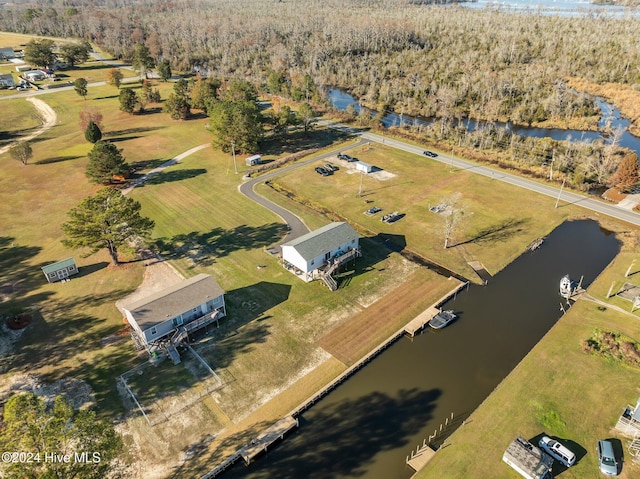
[282,222,360,289]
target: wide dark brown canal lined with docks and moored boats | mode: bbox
[224,220,620,479]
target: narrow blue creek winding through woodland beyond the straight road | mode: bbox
[327,88,640,158]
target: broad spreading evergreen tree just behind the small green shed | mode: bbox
[62,187,155,265]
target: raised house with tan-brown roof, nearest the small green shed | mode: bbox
[122,274,227,352]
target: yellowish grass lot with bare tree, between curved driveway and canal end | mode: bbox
[273,144,584,279]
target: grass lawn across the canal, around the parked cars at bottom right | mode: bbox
[418,296,640,479]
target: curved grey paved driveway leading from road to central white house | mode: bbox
[238,140,366,253]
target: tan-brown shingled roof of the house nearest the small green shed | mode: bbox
[122,274,224,331]
